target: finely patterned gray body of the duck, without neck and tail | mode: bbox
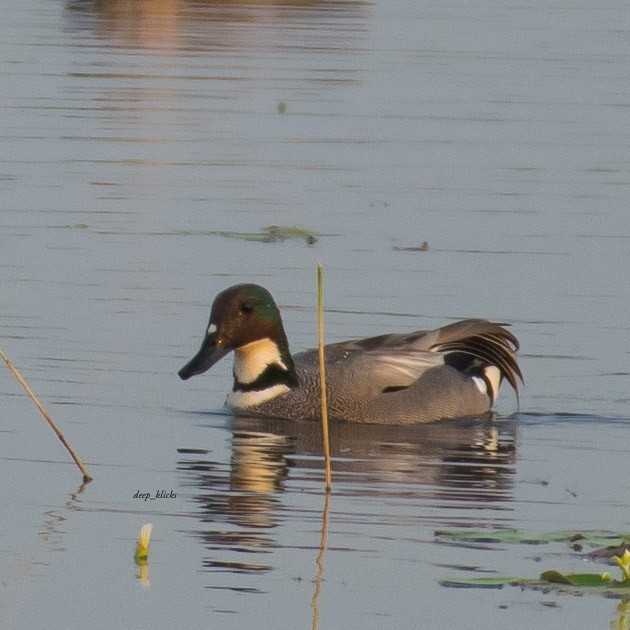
[236,331,508,424]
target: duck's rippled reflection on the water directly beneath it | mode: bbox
[179,418,516,573]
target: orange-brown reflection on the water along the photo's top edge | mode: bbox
[65,0,369,56]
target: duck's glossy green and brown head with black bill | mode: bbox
[179,284,295,380]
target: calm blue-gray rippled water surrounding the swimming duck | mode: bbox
[0,0,630,629]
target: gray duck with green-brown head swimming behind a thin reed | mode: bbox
[178,284,523,425]
